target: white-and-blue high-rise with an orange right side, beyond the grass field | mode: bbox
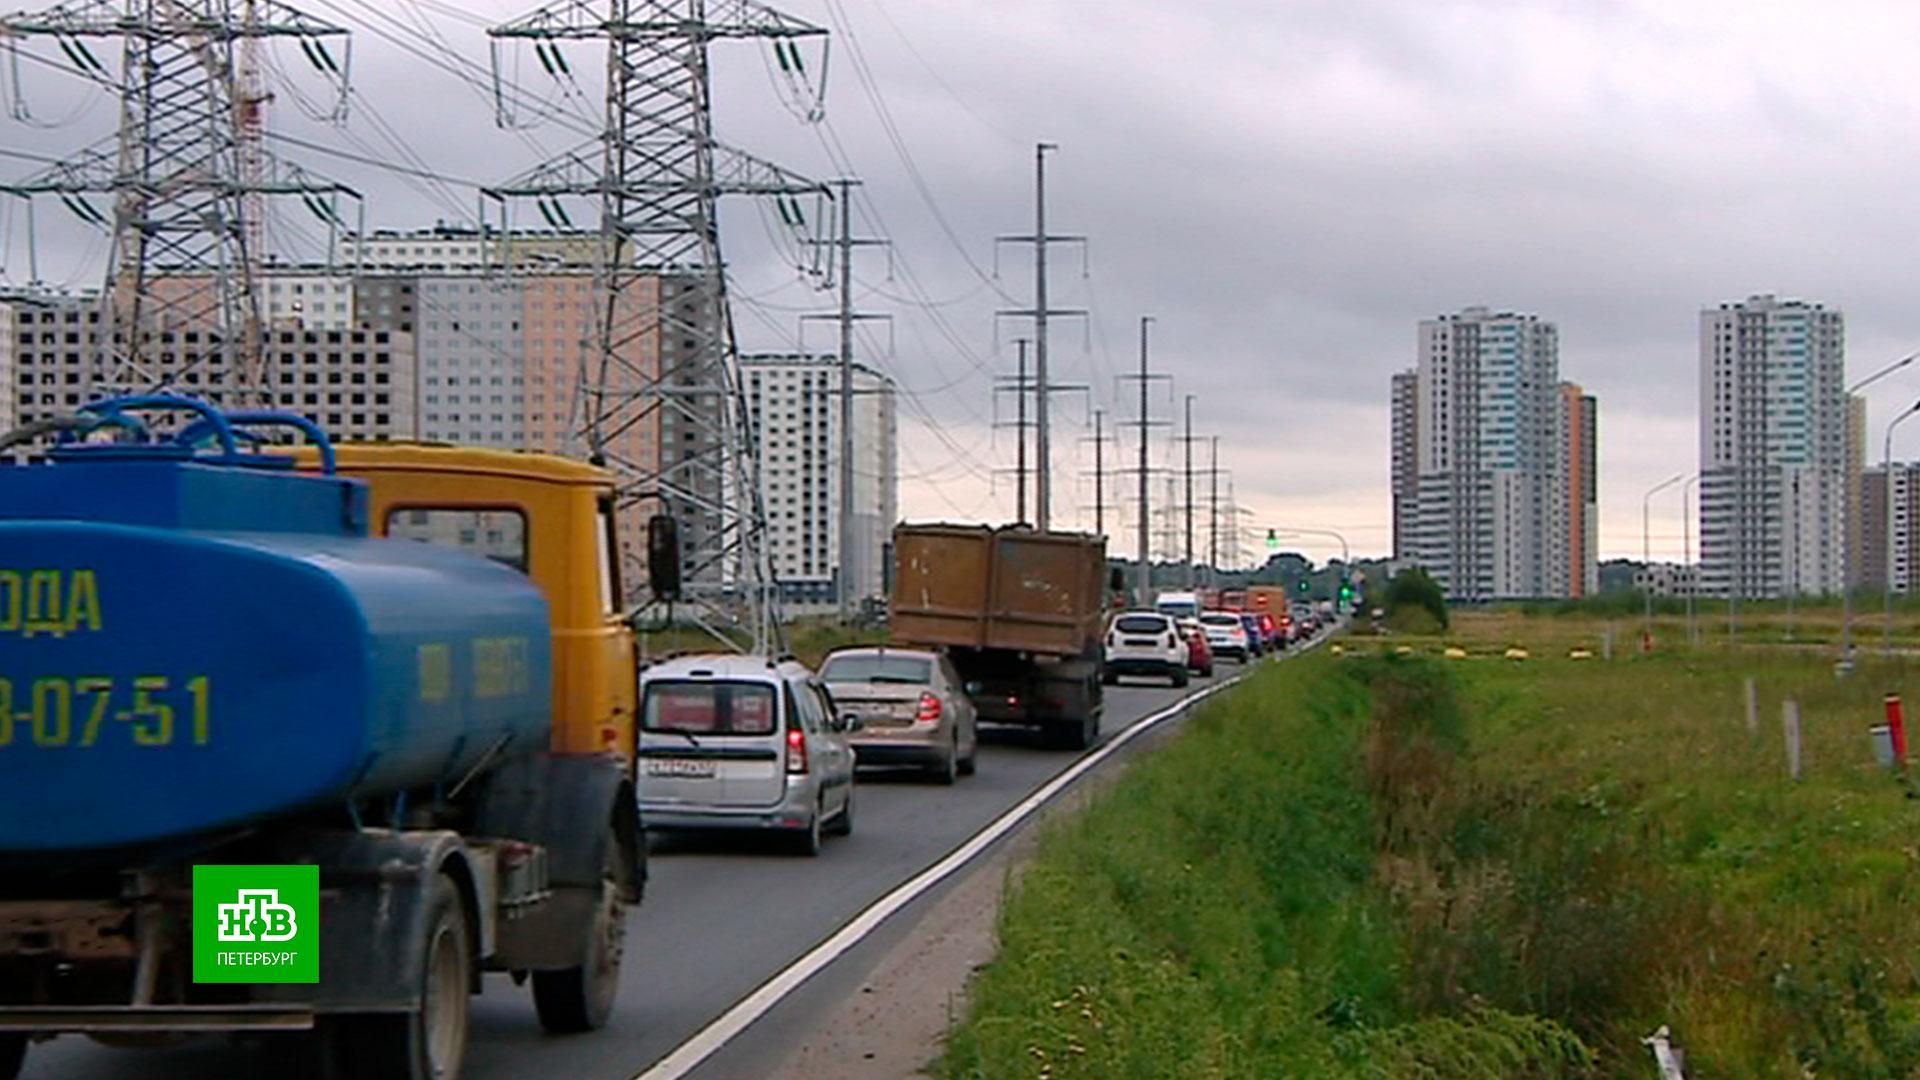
[1394,307,1586,601]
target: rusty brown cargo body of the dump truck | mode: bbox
[891,525,1106,657]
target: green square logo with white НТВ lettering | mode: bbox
[194,867,321,982]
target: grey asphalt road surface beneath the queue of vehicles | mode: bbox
[23,665,1235,1080]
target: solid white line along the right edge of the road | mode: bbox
[634,638,1325,1080]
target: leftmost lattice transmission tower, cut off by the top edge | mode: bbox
[0,0,359,405]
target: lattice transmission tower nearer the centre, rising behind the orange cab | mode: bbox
[486,0,828,651]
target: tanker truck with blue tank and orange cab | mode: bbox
[0,396,645,1080]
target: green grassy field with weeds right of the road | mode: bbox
[941,617,1920,1078]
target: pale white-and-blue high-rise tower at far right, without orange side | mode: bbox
[1699,296,1847,598]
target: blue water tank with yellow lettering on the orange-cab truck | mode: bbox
[0,399,551,859]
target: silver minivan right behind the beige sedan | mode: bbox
[639,655,858,855]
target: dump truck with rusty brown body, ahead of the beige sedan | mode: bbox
[891,525,1110,749]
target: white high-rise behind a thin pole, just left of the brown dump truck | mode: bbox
[741,356,899,609]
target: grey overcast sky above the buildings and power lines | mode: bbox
[0,0,1920,557]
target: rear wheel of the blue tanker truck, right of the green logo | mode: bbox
[334,874,474,1080]
